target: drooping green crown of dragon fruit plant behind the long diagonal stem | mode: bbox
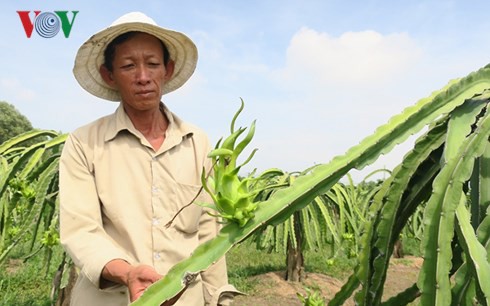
[251,169,390,261]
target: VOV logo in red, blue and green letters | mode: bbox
[17,11,78,38]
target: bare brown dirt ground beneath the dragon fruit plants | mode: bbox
[233,256,422,306]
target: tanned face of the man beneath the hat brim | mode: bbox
[101,33,173,111]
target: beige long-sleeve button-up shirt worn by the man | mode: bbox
[60,104,235,306]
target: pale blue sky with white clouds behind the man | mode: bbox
[0,0,490,180]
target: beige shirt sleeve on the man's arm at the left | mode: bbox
[59,134,131,288]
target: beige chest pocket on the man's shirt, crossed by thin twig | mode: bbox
[173,182,207,234]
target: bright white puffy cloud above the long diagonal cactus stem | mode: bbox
[280,28,421,85]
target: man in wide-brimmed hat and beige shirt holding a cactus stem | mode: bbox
[60,13,235,306]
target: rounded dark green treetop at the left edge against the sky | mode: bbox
[0,101,32,144]
